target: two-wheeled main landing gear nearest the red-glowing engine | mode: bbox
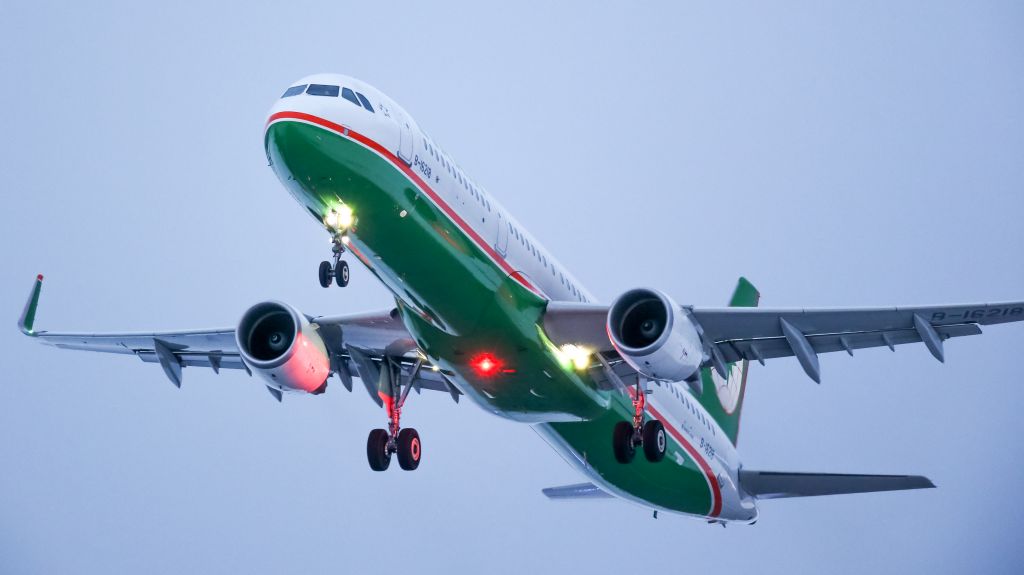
[367,356,423,472]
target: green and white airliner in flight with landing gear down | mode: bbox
[18,74,1024,525]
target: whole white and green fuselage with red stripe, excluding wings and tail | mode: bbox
[265,75,757,522]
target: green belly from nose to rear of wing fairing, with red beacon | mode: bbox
[266,117,608,423]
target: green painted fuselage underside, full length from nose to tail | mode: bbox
[264,77,756,520]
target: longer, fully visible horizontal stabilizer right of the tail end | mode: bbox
[739,471,935,499]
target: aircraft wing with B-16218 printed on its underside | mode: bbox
[544,294,1024,383]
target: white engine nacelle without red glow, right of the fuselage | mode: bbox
[607,289,703,382]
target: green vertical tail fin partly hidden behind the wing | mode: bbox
[699,277,761,445]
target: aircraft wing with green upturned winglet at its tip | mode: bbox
[18,275,459,404]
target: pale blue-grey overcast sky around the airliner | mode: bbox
[0,1,1024,574]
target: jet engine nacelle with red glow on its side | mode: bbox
[234,302,331,393]
